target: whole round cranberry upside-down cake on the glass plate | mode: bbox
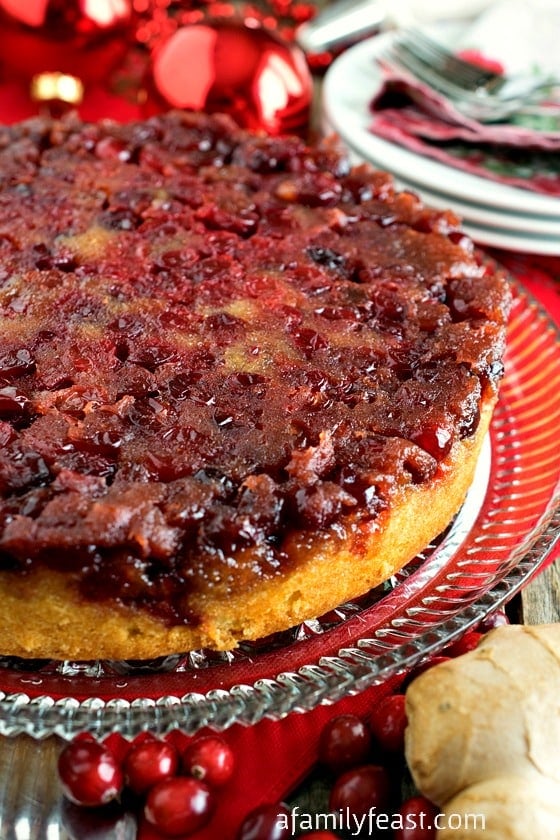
[0,113,509,659]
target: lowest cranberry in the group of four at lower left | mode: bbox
[144,776,215,837]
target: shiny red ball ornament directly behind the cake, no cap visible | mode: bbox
[144,18,312,135]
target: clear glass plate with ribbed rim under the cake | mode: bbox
[0,278,560,738]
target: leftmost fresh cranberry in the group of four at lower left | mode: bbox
[58,739,123,808]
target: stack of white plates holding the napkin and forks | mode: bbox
[322,33,560,256]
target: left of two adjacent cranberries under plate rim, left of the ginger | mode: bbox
[319,715,371,773]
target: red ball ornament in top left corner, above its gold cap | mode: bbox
[0,0,132,83]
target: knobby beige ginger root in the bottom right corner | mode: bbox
[406,624,560,840]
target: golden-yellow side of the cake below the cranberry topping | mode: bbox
[0,396,496,659]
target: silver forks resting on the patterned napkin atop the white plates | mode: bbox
[386,30,559,122]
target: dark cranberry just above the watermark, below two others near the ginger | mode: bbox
[329,764,391,817]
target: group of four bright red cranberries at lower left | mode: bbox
[58,735,235,837]
